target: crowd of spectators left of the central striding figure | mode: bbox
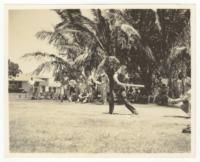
[55,75,108,103]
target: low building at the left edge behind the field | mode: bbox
[8,74,60,99]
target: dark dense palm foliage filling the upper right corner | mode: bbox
[120,9,190,95]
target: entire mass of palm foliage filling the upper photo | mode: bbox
[21,9,190,111]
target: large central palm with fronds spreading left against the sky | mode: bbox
[24,9,154,113]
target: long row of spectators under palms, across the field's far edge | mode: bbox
[30,73,191,109]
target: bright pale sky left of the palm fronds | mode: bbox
[8,9,90,73]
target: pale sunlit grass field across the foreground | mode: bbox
[9,101,191,153]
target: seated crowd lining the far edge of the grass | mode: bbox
[32,74,191,105]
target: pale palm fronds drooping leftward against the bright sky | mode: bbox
[22,10,84,82]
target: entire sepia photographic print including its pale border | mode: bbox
[6,4,195,157]
